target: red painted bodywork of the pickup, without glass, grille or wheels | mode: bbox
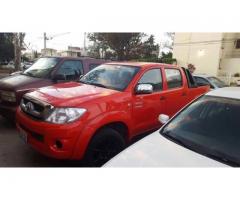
[17,63,209,159]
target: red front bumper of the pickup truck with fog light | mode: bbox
[16,109,82,159]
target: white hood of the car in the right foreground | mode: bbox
[104,131,227,167]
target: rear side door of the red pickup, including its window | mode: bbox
[164,68,187,117]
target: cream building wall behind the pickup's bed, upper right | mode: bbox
[173,33,223,76]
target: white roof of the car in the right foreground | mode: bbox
[206,87,240,99]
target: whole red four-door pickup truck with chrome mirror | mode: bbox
[17,62,209,166]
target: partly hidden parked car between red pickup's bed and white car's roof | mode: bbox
[194,74,228,89]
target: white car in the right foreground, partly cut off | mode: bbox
[105,87,240,167]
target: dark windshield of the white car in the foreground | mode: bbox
[161,96,240,166]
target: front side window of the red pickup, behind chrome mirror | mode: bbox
[138,69,162,92]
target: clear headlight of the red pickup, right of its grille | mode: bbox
[46,108,87,124]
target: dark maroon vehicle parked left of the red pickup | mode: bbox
[0,57,106,119]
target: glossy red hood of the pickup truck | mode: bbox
[29,82,119,107]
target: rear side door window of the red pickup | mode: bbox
[165,69,182,89]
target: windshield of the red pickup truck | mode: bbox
[80,64,139,91]
